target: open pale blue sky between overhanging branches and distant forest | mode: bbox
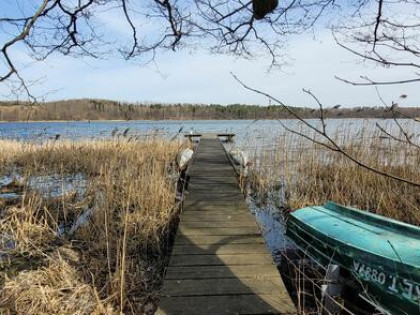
[0,1,420,107]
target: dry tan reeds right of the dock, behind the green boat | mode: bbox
[251,130,420,225]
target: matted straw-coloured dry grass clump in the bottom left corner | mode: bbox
[1,247,115,314]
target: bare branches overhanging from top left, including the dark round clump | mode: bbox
[0,0,352,99]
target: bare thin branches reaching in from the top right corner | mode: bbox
[333,0,420,86]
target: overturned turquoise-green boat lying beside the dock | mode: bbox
[286,202,420,315]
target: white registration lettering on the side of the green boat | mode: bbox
[352,260,420,302]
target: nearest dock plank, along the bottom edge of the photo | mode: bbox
[156,294,297,315]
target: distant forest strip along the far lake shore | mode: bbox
[0,99,420,121]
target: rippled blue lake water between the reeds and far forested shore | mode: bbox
[0,119,420,147]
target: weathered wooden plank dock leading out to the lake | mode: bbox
[157,137,297,314]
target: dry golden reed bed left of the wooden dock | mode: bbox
[0,138,181,314]
